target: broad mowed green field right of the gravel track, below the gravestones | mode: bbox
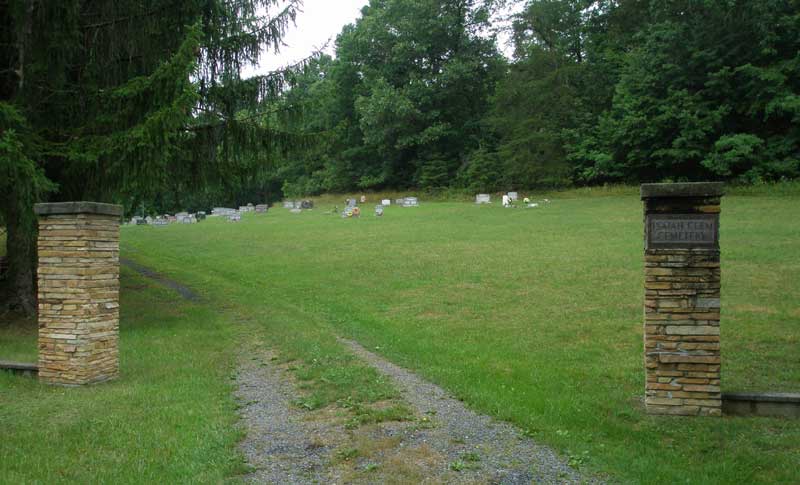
[0,191,800,483]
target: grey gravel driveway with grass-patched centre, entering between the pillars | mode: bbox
[231,340,597,484]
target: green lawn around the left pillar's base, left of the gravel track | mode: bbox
[0,271,248,483]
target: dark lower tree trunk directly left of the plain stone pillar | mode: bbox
[6,199,38,316]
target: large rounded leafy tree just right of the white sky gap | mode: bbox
[272,0,503,193]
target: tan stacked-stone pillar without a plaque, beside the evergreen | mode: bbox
[34,202,122,385]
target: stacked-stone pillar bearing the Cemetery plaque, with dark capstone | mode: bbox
[641,183,722,416]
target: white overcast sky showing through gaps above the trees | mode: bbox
[243,0,522,77]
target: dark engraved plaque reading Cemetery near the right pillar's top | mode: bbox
[645,214,719,249]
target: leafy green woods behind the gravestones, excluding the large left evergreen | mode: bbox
[271,0,800,199]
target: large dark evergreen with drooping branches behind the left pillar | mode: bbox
[0,0,300,312]
